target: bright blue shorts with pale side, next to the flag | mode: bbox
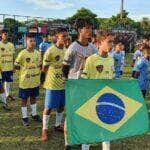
[45,89,65,109]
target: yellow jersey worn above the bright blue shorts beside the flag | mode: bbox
[43,45,65,90]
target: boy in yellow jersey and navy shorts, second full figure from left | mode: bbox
[15,34,42,126]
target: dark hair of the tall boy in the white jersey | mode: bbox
[74,18,93,30]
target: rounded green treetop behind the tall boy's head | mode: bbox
[66,8,99,28]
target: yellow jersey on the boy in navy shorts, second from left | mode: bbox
[15,49,41,89]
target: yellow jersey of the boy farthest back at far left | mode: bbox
[0,42,15,71]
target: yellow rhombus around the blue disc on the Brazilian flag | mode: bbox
[76,86,142,132]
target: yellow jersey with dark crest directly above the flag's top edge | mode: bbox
[82,54,114,79]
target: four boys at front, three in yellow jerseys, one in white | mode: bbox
[0,19,122,150]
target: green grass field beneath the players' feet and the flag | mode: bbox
[0,55,150,150]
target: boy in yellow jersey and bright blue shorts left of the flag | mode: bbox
[42,28,68,141]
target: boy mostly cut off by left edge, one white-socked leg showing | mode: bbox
[0,55,10,110]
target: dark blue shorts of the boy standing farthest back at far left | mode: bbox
[2,71,13,82]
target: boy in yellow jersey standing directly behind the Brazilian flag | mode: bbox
[82,31,114,150]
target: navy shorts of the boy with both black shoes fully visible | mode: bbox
[19,87,39,100]
